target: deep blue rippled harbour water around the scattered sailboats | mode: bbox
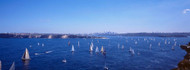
[0,36,190,70]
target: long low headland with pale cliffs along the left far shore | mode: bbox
[0,33,104,39]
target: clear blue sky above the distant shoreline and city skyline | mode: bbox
[0,0,190,33]
